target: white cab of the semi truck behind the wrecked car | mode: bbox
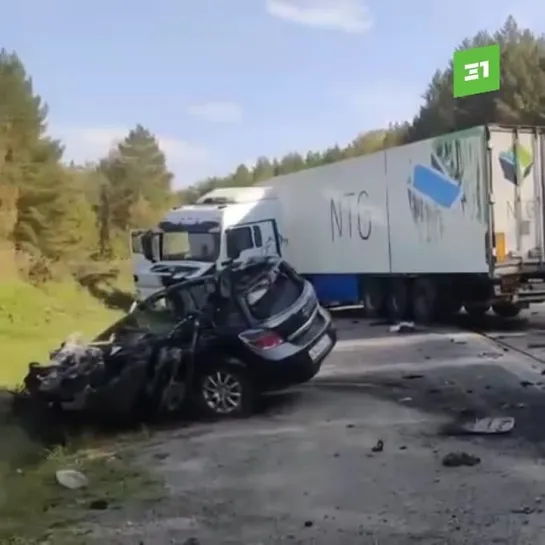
[131,187,282,300]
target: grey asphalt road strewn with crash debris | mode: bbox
[85,310,545,545]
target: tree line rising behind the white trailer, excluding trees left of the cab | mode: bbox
[178,17,545,202]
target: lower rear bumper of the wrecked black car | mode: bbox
[256,325,337,391]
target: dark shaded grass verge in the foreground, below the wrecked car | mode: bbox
[0,412,164,545]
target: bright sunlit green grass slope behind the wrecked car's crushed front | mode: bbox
[0,281,122,387]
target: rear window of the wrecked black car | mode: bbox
[246,266,303,320]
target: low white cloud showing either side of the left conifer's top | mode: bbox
[50,127,209,164]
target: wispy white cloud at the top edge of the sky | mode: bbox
[266,0,373,34]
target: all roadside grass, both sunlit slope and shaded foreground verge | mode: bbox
[0,274,163,545]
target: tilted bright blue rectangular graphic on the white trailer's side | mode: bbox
[412,154,462,208]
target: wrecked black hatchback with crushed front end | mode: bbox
[25,258,336,417]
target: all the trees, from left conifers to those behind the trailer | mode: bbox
[0,17,545,279]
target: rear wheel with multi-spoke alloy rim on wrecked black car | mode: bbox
[196,365,255,418]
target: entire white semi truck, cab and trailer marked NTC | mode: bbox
[133,126,545,321]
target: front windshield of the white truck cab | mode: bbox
[161,231,220,263]
